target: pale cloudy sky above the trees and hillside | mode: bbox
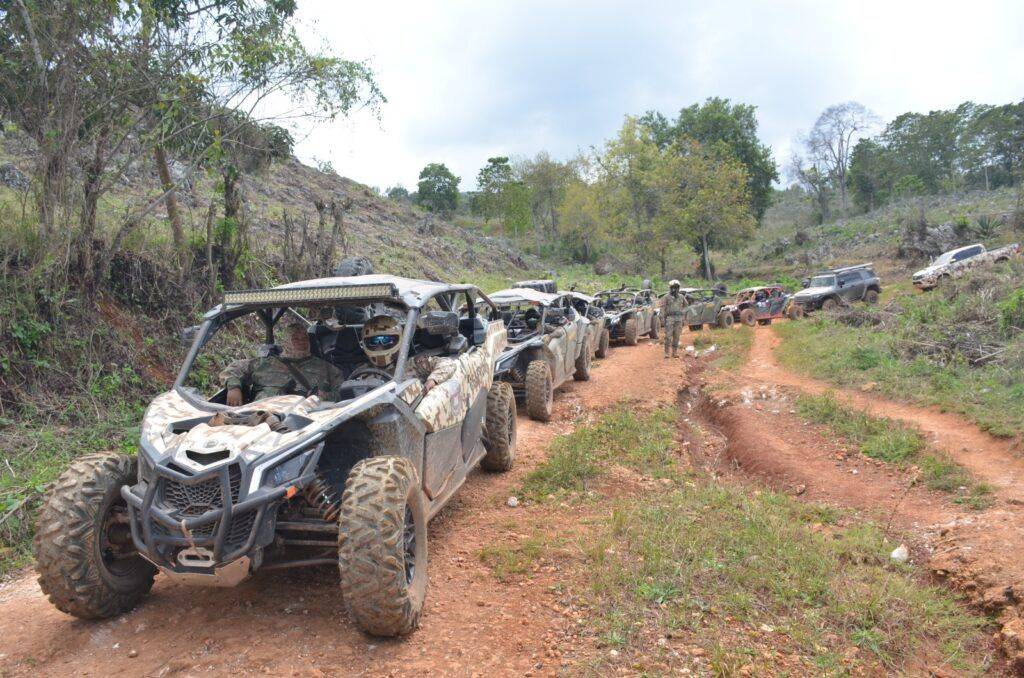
[286,0,1024,190]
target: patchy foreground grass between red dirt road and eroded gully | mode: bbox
[520,402,987,675]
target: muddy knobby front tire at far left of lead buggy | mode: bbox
[35,452,157,620]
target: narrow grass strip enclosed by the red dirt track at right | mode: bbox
[797,392,992,509]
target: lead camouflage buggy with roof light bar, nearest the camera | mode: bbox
[36,274,516,636]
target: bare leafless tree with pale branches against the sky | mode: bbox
[804,101,878,210]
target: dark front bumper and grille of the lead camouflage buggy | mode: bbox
[121,462,311,576]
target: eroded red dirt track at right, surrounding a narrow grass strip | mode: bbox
[706,328,1024,674]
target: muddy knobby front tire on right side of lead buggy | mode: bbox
[338,457,427,636]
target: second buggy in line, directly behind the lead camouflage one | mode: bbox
[490,288,592,421]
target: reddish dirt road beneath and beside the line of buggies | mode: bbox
[0,342,685,676]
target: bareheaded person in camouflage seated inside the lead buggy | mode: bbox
[220,316,344,408]
